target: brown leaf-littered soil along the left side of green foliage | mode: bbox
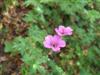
[0,0,29,75]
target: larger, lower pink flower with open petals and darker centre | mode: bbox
[43,35,66,52]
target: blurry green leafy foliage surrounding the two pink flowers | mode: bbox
[0,0,100,75]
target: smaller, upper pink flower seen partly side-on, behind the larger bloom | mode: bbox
[55,26,73,36]
